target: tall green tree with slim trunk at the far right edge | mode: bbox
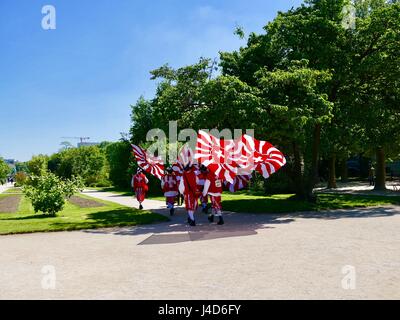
[347,1,400,190]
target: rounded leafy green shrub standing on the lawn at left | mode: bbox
[23,173,83,216]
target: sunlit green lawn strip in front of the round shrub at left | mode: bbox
[0,194,168,235]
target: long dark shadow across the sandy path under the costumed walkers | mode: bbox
[85,206,400,245]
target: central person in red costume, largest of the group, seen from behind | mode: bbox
[179,165,199,227]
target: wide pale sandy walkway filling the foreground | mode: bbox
[0,193,400,299]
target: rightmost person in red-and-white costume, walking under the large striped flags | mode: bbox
[203,172,224,225]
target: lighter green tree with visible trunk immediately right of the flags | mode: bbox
[256,60,333,200]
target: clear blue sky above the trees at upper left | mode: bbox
[0,0,302,161]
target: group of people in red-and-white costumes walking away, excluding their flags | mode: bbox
[132,164,224,226]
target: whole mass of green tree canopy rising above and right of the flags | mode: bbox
[131,0,400,200]
